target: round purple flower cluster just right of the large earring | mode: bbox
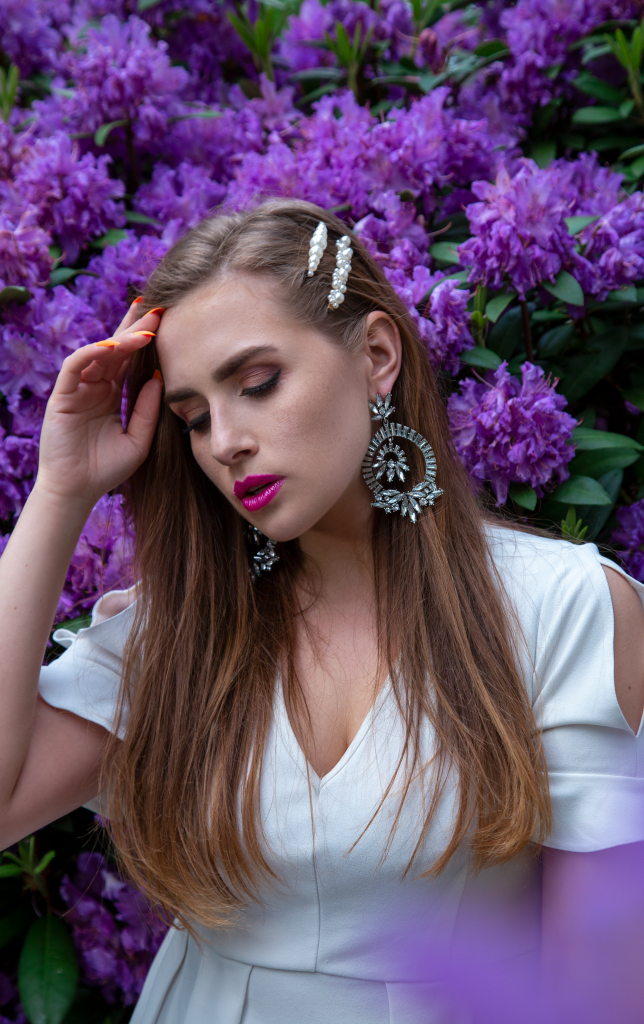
[447,362,576,505]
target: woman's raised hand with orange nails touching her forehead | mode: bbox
[36,304,163,509]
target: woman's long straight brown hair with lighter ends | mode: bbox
[105,201,550,930]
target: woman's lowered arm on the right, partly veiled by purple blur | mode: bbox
[543,567,644,1024]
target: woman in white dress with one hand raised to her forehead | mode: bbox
[0,201,644,1024]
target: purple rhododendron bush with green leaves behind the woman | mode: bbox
[0,0,644,1024]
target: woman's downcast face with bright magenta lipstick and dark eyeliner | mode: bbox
[157,275,399,541]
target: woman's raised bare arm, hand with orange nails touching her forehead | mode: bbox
[0,303,162,849]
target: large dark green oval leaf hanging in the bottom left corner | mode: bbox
[18,913,79,1024]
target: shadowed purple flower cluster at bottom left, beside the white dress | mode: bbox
[60,853,168,1007]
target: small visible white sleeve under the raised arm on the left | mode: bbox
[38,588,135,735]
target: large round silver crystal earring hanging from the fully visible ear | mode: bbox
[362,392,442,522]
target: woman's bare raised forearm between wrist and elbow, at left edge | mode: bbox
[0,482,91,808]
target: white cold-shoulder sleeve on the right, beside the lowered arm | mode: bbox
[492,531,644,852]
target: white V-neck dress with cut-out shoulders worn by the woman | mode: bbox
[40,528,644,1024]
